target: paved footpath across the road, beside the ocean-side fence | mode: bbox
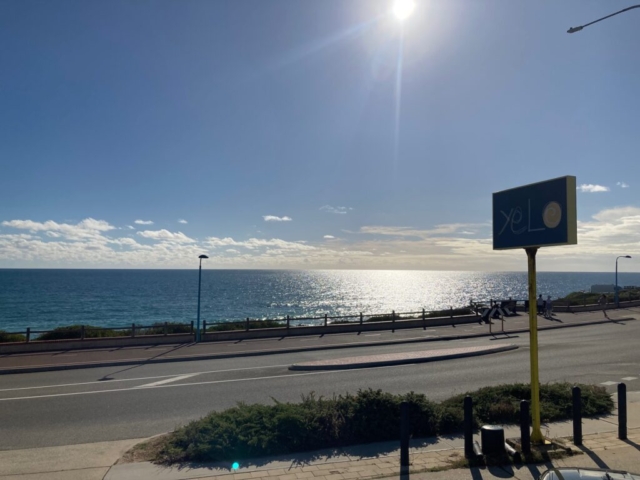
[0,308,640,375]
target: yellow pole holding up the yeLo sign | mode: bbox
[525,247,544,443]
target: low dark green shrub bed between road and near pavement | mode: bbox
[154,383,613,463]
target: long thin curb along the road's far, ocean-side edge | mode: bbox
[0,317,636,376]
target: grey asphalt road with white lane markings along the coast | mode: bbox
[0,320,640,450]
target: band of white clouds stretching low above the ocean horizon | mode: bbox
[0,206,640,271]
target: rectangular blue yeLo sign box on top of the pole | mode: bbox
[493,176,578,250]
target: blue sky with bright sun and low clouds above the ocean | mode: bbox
[0,0,640,272]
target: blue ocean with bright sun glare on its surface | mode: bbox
[0,269,640,331]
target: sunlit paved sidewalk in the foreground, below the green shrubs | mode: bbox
[0,392,640,480]
